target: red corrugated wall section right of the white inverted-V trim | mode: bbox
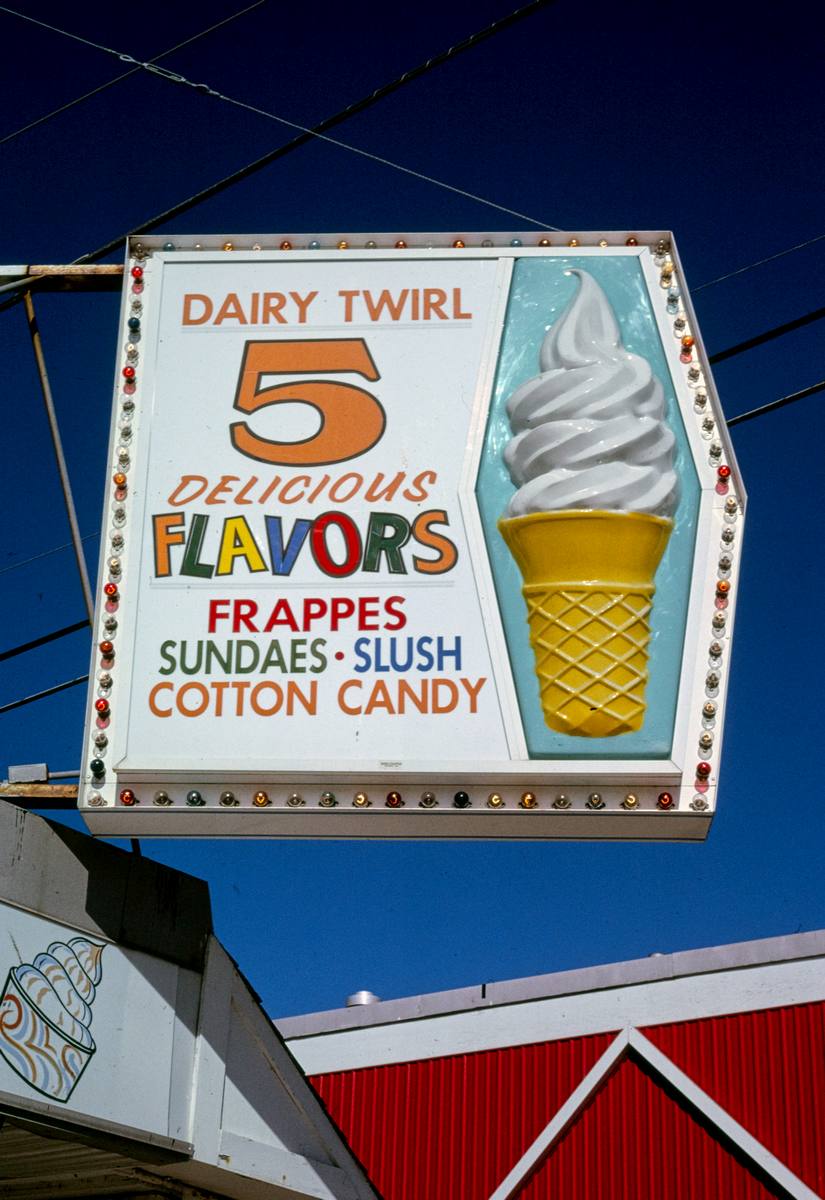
[643,1003,825,1195]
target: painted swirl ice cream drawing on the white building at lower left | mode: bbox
[0,937,103,1103]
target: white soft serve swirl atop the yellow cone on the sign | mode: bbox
[504,271,679,517]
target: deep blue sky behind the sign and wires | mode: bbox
[0,0,825,1015]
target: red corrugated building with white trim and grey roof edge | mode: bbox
[278,931,825,1200]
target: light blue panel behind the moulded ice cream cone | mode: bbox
[477,256,699,758]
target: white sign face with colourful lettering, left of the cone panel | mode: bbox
[133,256,507,773]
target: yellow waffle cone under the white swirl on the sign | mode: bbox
[499,509,673,738]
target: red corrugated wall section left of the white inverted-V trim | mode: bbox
[312,1033,614,1200]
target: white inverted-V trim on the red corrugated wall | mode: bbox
[489,1027,820,1200]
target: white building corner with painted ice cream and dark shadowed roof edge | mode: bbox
[0,804,375,1200]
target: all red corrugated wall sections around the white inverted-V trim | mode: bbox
[313,1003,825,1200]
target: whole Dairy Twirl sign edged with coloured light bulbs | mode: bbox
[80,233,743,839]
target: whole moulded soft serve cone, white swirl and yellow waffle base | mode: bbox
[499,271,679,737]
